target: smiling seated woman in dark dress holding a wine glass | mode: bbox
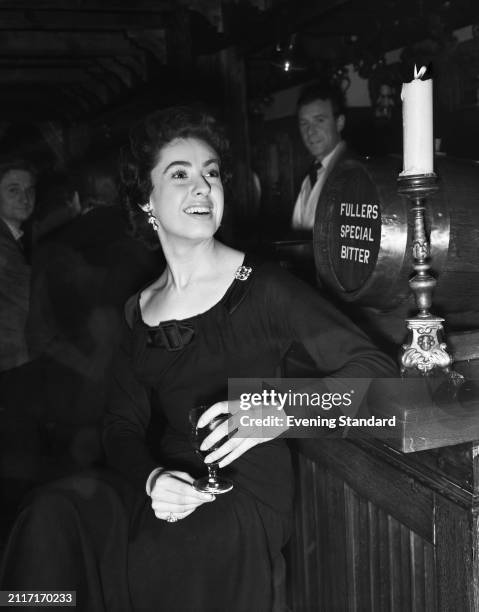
[3,108,393,612]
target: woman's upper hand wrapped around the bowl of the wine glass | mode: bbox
[198,400,288,467]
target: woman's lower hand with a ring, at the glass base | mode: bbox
[150,470,215,521]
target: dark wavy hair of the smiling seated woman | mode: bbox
[120,106,229,248]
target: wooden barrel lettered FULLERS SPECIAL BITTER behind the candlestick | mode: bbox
[313,156,479,329]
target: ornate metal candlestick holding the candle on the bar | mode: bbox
[398,174,463,384]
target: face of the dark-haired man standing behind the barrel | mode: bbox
[298,99,344,161]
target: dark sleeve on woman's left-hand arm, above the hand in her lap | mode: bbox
[103,324,158,491]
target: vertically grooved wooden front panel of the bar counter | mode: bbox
[287,457,440,612]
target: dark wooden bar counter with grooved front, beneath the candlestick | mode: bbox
[286,358,479,612]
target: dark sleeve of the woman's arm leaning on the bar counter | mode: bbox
[260,270,398,424]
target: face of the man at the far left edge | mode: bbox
[0,170,35,227]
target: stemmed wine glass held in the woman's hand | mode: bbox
[188,406,233,495]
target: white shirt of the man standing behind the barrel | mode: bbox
[291,140,346,230]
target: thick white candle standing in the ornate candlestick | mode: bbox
[401,66,434,175]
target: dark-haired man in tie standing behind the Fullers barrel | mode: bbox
[291,83,348,230]
